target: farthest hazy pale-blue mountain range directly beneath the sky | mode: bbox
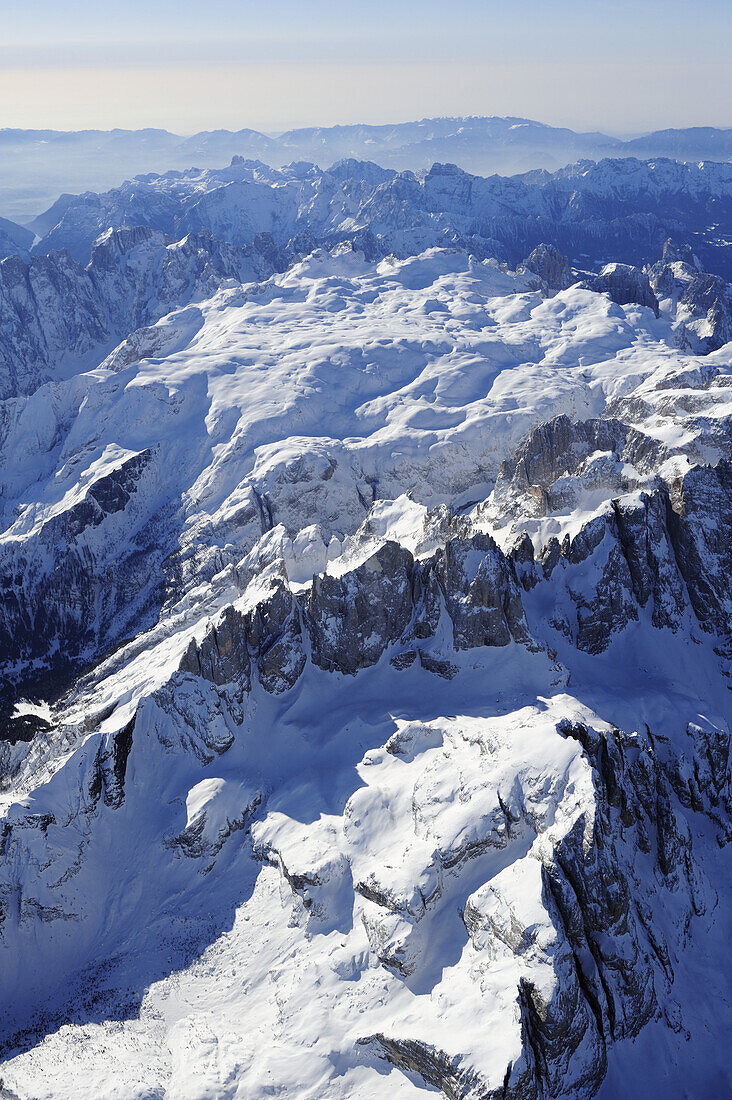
[0,118,732,223]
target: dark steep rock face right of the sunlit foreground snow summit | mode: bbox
[544,722,709,1091]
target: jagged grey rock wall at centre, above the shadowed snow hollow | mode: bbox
[181,535,531,693]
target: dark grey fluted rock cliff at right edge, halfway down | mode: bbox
[511,462,732,653]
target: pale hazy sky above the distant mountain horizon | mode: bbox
[0,0,732,133]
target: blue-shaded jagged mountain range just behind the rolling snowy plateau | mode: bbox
[19,158,732,279]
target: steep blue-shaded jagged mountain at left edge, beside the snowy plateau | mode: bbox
[0,226,289,398]
